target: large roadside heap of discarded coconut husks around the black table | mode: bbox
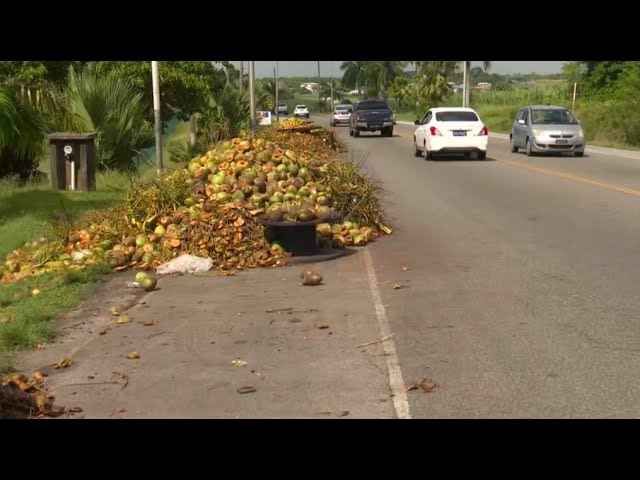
[0,131,391,281]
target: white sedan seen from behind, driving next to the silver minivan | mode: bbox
[413,107,489,160]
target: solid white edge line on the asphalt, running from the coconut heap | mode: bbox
[364,248,411,419]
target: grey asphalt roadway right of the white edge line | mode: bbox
[316,114,640,418]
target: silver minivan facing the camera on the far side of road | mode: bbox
[509,105,586,157]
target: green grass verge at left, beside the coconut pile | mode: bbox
[0,122,189,371]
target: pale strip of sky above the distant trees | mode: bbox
[242,60,565,78]
